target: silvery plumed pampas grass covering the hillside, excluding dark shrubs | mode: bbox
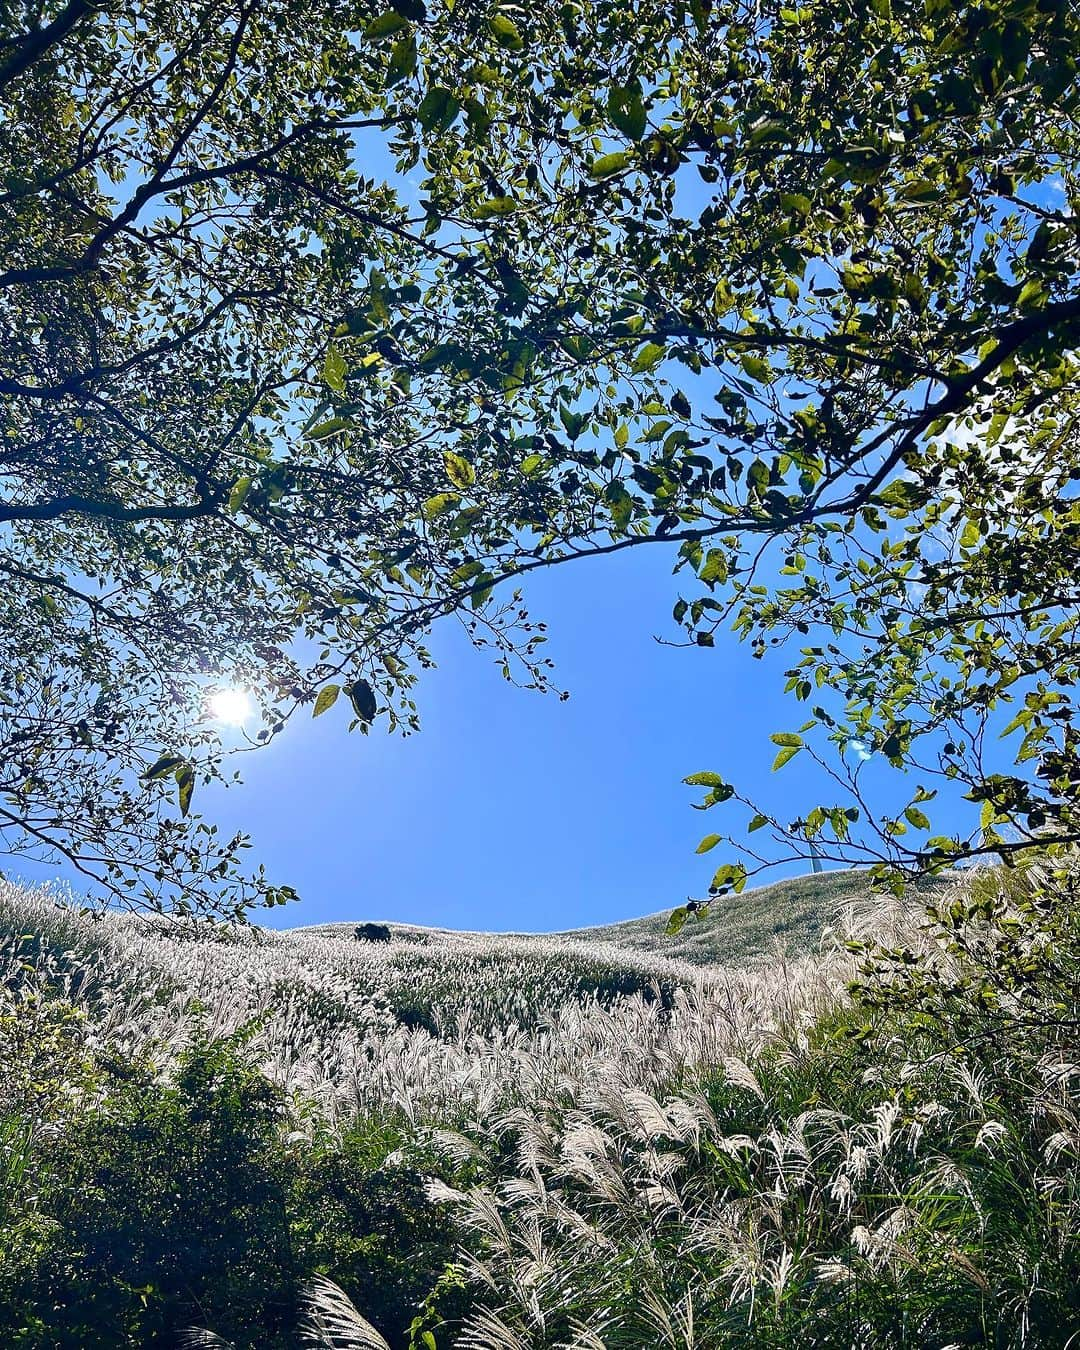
[8,864,1080,1350]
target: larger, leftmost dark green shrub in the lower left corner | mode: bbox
[0,1042,296,1350]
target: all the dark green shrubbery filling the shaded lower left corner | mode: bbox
[0,1041,460,1350]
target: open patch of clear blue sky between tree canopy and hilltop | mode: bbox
[3,526,837,932]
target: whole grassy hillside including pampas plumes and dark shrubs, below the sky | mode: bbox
[0,868,1080,1350]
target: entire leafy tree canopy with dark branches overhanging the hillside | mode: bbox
[0,0,1080,909]
